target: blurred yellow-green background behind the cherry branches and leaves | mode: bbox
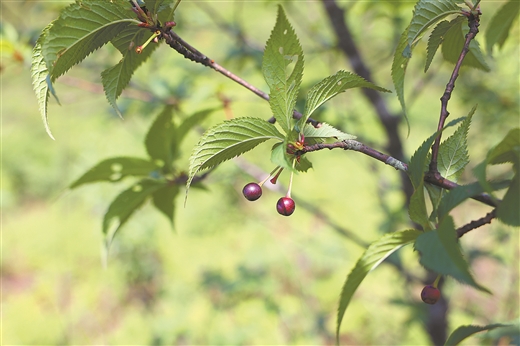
[0,1,520,345]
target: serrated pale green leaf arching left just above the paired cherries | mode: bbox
[186,118,284,194]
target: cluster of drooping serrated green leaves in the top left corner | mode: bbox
[31,0,177,138]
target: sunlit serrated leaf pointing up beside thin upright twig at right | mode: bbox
[438,106,477,182]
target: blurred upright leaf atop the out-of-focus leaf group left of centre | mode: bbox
[144,105,175,172]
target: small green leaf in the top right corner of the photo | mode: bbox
[486,0,520,53]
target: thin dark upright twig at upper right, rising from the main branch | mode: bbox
[429,12,480,176]
